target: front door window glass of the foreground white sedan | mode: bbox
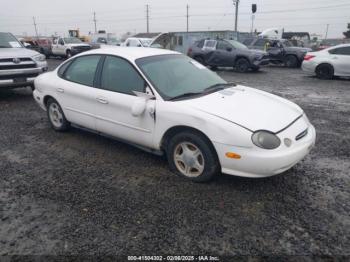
[101,56,145,95]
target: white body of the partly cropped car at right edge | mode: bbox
[302,44,350,77]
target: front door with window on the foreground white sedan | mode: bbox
[96,56,155,147]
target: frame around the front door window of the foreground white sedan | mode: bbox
[94,54,155,96]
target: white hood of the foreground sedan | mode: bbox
[179,86,303,133]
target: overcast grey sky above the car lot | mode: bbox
[0,0,350,38]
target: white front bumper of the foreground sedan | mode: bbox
[213,120,316,178]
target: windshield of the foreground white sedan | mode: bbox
[136,55,227,100]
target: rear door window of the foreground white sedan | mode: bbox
[63,55,101,86]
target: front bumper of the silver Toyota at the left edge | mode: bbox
[0,61,48,88]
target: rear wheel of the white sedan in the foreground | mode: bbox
[46,98,70,132]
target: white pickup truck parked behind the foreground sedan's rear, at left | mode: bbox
[51,37,91,58]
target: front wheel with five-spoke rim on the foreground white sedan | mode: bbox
[166,132,220,182]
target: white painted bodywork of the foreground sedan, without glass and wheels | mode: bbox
[33,47,316,177]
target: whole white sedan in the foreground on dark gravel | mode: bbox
[33,47,316,182]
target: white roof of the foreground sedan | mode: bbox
[74,46,181,61]
